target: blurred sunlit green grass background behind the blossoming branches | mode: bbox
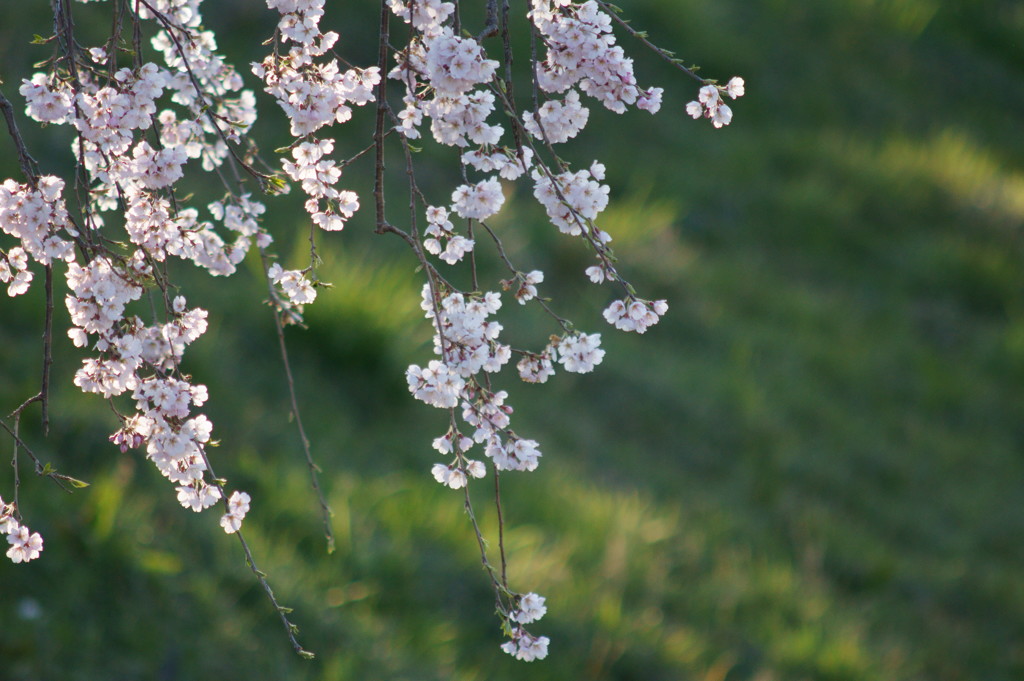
[0,0,1024,681]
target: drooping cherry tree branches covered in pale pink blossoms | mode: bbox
[0,0,743,661]
